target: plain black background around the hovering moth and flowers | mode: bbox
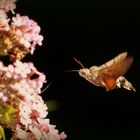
[16,0,140,140]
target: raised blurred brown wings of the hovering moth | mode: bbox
[99,52,133,79]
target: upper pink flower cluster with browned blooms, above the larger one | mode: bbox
[0,0,43,61]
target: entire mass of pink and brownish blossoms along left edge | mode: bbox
[0,0,66,140]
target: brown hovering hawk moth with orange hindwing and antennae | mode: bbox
[73,52,136,91]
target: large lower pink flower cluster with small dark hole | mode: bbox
[0,61,65,140]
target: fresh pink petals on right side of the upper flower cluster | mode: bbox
[11,14,43,54]
